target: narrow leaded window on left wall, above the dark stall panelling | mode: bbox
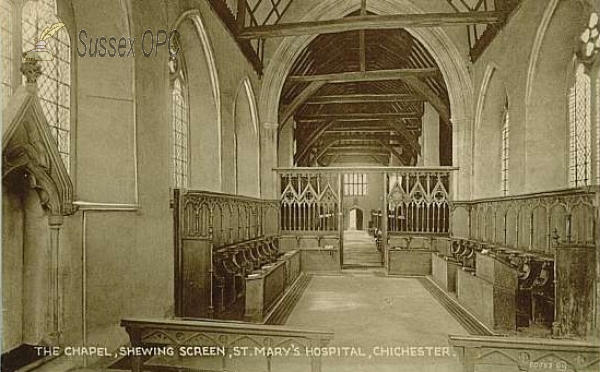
[169,39,190,188]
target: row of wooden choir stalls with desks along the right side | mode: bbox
[432,239,554,331]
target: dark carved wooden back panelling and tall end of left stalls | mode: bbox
[173,190,279,317]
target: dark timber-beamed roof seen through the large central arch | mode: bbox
[280,15,450,166]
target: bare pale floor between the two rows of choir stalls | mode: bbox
[286,270,468,372]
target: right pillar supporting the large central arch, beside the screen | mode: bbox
[450,118,473,200]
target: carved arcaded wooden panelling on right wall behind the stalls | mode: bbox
[453,189,598,254]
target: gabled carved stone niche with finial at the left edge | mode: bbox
[2,85,74,352]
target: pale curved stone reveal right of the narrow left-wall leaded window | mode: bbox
[171,9,223,191]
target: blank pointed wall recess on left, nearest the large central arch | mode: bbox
[233,77,260,197]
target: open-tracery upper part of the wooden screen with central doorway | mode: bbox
[278,167,455,234]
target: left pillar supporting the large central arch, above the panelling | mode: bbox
[260,123,279,199]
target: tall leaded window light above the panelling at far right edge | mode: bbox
[569,64,592,187]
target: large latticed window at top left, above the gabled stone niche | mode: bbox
[21,0,71,170]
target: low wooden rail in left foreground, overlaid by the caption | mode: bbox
[121,319,333,372]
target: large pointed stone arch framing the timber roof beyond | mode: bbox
[259,0,473,199]
